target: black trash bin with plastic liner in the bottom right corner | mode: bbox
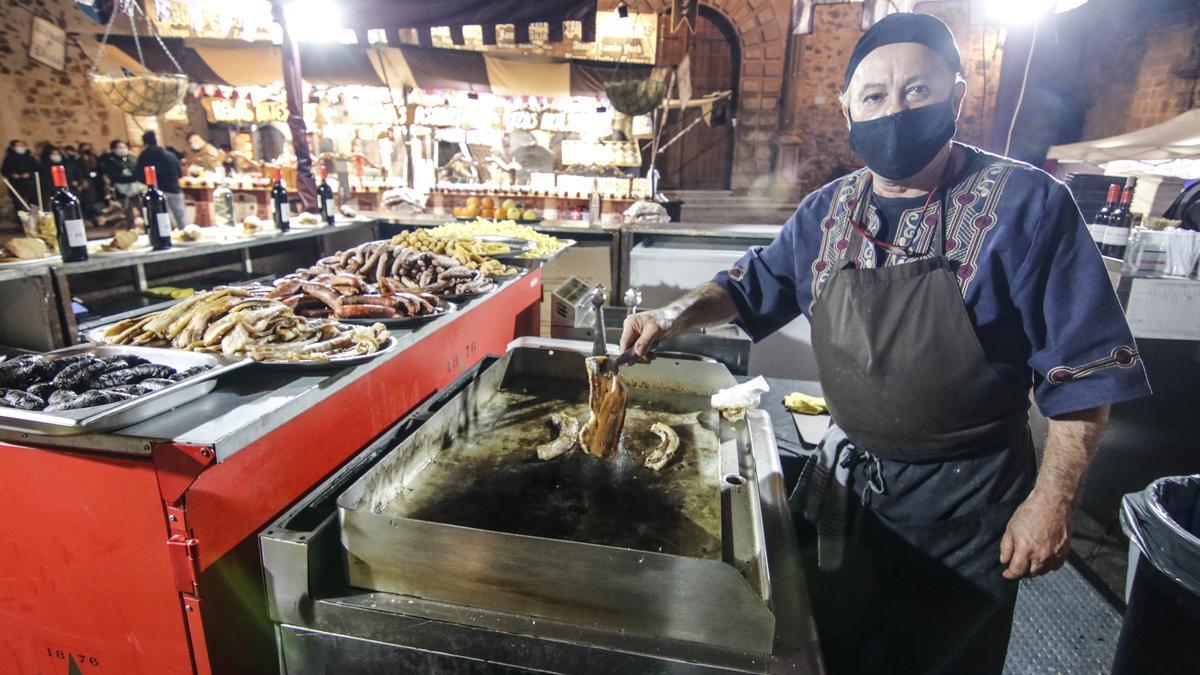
[1112,474,1200,675]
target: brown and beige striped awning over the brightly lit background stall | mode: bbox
[109,36,650,96]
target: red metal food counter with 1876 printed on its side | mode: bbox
[0,270,541,674]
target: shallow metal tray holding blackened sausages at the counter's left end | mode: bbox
[0,345,252,436]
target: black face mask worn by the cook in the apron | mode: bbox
[850,98,955,180]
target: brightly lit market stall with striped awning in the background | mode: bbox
[100,2,667,225]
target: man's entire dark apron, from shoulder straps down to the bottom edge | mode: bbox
[811,171,1034,673]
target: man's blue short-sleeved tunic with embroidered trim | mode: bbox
[714,142,1150,417]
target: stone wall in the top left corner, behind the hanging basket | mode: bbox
[0,0,125,153]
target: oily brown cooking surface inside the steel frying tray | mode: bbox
[382,384,721,560]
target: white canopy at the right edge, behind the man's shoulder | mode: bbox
[1046,108,1200,165]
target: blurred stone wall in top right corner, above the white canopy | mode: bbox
[1082,0,1200,139]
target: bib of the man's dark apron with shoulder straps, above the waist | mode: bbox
[812,178,1028,461]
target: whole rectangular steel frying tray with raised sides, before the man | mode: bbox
[337,346,775,655]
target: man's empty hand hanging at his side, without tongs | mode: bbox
[1000,490,1072,579]
